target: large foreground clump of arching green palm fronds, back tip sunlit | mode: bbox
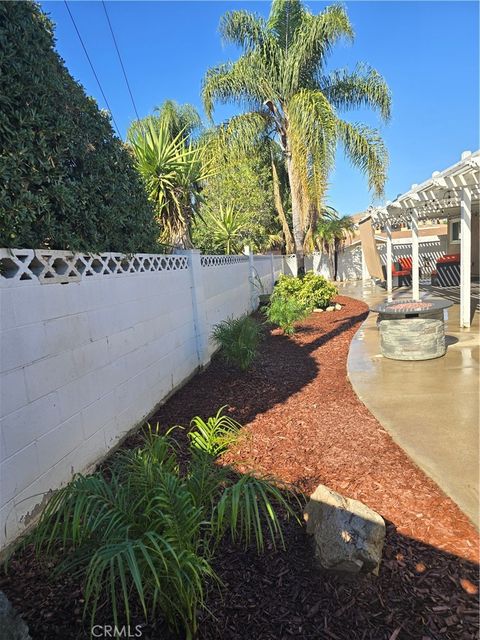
[33,410,294,639]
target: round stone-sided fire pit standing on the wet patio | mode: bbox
[371,300,453,360]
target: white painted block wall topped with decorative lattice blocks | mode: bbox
[0,250,283,548]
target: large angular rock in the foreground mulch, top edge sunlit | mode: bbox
[304,484,385,574]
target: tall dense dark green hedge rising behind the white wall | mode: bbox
[0,1,158,252]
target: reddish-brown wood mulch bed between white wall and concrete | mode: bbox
[0,297,478,640]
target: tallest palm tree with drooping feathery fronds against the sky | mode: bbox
[202,0,391,272]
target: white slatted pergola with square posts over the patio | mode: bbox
[369,151,480,327]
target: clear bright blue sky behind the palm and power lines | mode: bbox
[41,0,479,214]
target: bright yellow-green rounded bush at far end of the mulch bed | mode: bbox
[272,271,338,311]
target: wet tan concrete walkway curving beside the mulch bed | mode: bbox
[339,282,480,527]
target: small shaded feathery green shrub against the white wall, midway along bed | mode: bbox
[212,316,262,371]
